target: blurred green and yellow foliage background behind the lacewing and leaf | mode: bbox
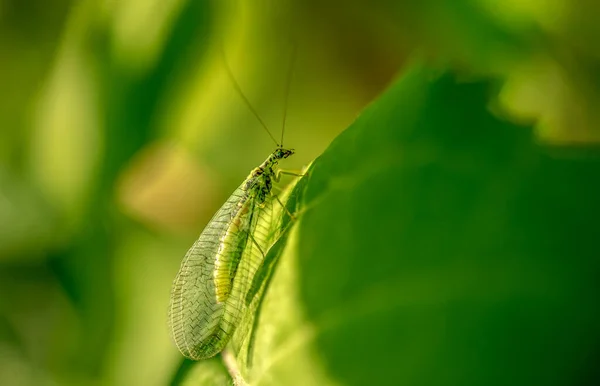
[0,0,600,385]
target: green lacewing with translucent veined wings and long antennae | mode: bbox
[169,47,298,360]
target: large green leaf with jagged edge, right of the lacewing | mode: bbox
[172,68,600,386]
